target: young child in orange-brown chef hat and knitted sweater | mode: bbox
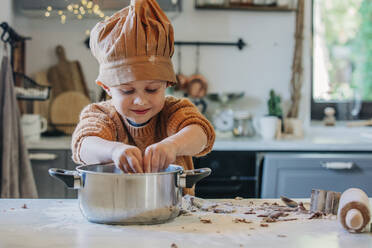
[72,0,215,194]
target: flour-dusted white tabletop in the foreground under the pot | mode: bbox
[0,199,372,248]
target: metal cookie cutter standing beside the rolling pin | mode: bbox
[310,189,341,215]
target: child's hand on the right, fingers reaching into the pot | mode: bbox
[143,141,177,173]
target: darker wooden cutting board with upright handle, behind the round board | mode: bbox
[48,45,89,98]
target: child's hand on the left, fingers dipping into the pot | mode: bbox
[112,144,143,173]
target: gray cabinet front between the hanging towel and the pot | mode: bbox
[29,149,77,198]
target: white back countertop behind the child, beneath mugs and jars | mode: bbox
[27,126,372,152]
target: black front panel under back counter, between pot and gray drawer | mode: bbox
[194,151,259,198]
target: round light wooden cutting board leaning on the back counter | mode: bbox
[50,91,90,134]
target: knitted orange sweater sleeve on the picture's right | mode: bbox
[165,97,215,157]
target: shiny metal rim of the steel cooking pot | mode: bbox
[76,163,184,177]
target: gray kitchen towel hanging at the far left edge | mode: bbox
[0,45,37,198]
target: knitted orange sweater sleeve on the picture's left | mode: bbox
[71,101,117,164]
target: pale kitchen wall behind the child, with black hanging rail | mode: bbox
[15,0,311,122]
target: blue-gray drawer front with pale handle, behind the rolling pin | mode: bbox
[261,153,372,198]
